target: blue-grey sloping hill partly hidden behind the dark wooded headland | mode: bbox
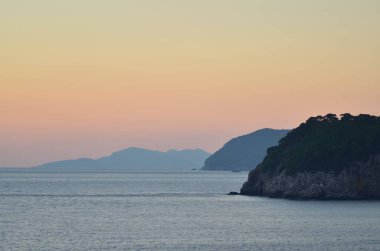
[202,128,289,171]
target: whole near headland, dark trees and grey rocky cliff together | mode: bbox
[240,114,380,199]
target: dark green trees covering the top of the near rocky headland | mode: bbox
[260,113,380,174]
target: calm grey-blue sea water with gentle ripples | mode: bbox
[0,171,380,251]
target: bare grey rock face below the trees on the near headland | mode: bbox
[240,154,380,199]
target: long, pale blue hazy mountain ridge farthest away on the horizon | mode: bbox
[34,147,210,169]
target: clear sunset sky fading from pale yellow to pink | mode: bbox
[0,0,380,166]
